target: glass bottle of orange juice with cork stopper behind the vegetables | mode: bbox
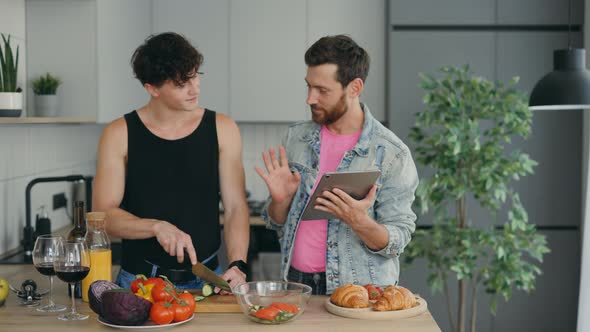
[82,212,112,302]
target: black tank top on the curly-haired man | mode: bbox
[121,110,221,271]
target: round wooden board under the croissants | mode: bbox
[324,296,428,320]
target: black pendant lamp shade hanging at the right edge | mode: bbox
[529,48,590,111]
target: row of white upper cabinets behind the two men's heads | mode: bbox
[26,0,387,123]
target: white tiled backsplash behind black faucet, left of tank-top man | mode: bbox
[0,124,102,254]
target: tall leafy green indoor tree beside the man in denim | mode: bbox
[405,66,549,332]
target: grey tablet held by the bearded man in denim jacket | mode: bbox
[301,170,381,220]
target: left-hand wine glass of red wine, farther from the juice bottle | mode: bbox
[33,235,66,312]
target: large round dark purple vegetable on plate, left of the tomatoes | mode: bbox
[101,289,152,326]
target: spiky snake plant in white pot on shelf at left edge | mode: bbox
[0,34,23,117]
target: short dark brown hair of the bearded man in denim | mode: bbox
[305,35,371,86]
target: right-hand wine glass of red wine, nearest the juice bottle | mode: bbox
[53,238,90,320]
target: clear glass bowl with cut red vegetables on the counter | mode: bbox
[232,281,311,324]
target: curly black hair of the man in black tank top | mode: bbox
[131,32,203,87]
